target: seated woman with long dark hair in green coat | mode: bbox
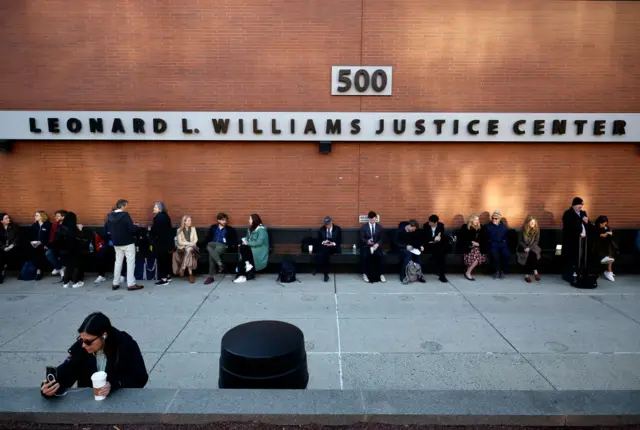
[233,214,269,284]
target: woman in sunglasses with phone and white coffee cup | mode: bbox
[40,312,149,398]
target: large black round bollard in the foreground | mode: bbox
[218,321,309,389]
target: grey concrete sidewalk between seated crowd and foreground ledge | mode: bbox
[0,274,640,390]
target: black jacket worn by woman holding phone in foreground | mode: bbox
[44,329,149,394]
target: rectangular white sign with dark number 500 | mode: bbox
[331,66,391,96]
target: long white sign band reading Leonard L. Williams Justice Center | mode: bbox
[0,111,640,142]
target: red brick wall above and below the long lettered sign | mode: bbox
[0,0,640,227]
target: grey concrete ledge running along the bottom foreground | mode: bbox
[0,388,640,428]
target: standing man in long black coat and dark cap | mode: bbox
[562,197,590,282]
